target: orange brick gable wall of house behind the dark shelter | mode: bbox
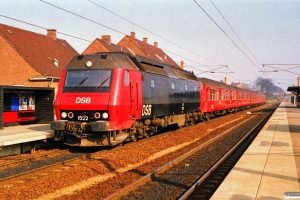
[0,36,57,88]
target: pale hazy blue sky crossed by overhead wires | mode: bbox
[0,0,300,91]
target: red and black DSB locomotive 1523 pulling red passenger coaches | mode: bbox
[51,52,266,146]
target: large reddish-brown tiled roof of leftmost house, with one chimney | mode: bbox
[0,24,78,77]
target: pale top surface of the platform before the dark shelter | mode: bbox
[0,124,54,146]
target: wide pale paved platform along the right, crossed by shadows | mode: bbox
[211,102,300,200]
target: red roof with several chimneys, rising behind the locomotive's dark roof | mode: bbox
[118,32,180,68]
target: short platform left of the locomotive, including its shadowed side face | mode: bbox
[0,124,54,157]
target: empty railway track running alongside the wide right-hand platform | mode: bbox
[105,105,278,200]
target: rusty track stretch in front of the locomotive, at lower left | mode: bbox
[0,147,108,187]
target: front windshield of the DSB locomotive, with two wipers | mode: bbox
[63,70,112,92]
